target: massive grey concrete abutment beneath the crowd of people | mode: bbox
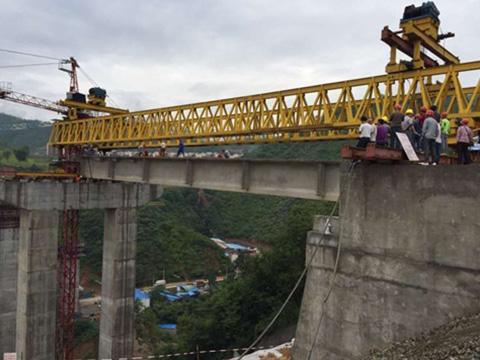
[294,164,480,360]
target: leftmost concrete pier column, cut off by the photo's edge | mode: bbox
[0,207,19,358]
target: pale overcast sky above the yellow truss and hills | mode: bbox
[0,0,480,120]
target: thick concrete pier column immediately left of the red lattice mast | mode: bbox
[16,210,59,360]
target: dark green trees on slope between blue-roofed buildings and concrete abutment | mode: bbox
[137,198,332,358]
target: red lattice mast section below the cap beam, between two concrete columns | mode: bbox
[56,210,79,360]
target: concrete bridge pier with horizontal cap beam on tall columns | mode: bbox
[0,181,160,360]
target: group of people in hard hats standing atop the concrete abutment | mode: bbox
[357,104,473,165]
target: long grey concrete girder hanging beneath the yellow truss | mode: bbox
[81,157,340,201]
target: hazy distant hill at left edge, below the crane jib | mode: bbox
[0,113,51,155]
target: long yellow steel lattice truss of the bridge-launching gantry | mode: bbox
[50,61,480,148]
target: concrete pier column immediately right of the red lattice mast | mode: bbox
[99,208,137,360]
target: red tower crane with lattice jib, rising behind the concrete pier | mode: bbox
[0,57,128,360]
